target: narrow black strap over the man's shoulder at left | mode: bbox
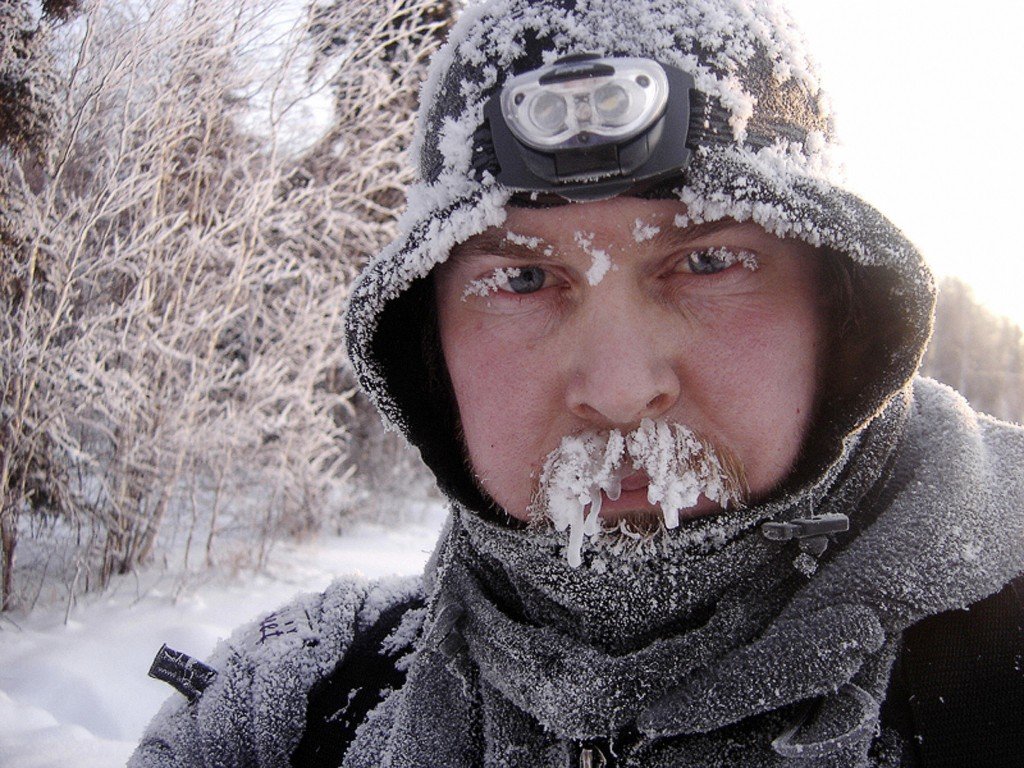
[291,597,423,768]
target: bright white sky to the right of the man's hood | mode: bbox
[784,0,1024,325]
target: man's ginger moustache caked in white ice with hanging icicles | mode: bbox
[530,419,745,568]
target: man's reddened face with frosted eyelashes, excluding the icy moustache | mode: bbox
[436,198,822,521]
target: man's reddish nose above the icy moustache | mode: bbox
[566,306,680,427]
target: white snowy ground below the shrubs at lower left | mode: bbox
[0,508,443,768]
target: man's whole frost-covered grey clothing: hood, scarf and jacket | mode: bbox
[130,0,1024,768]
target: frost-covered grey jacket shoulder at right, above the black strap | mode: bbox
[778,379,1024,630]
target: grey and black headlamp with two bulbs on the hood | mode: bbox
[484,54,693,200]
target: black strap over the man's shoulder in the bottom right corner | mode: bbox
[883,575,1024,768]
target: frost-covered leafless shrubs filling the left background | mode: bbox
[0,0,446,606]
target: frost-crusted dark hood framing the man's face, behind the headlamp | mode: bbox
[347,0,934,518]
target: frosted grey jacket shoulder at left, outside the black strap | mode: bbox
[128,577,423,768]
